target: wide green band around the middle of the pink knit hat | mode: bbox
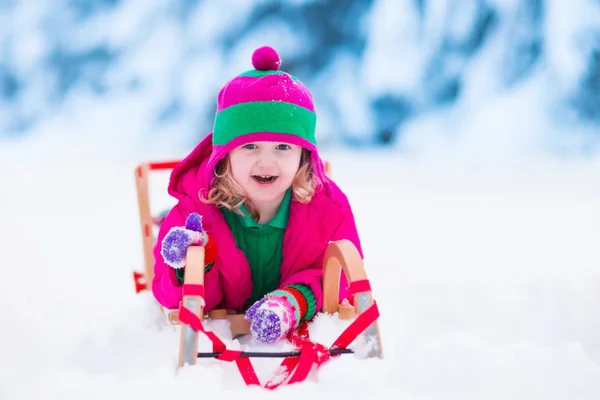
[213,101,317,145]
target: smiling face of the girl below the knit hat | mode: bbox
[229,142,302,204]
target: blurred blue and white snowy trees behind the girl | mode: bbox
[0,0,600,161]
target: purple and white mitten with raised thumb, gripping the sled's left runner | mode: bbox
[160,213,208,269]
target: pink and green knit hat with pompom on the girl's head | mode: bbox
[207,46,322,180]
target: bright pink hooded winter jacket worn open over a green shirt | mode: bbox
[152,134,362,312]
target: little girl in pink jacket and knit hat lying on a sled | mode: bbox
[152,46,362,343]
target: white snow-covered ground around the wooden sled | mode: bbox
[0,148,600,400]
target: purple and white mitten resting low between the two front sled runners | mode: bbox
[246,296,296,344]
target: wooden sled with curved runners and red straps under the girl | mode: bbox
[134,161,383,389]
